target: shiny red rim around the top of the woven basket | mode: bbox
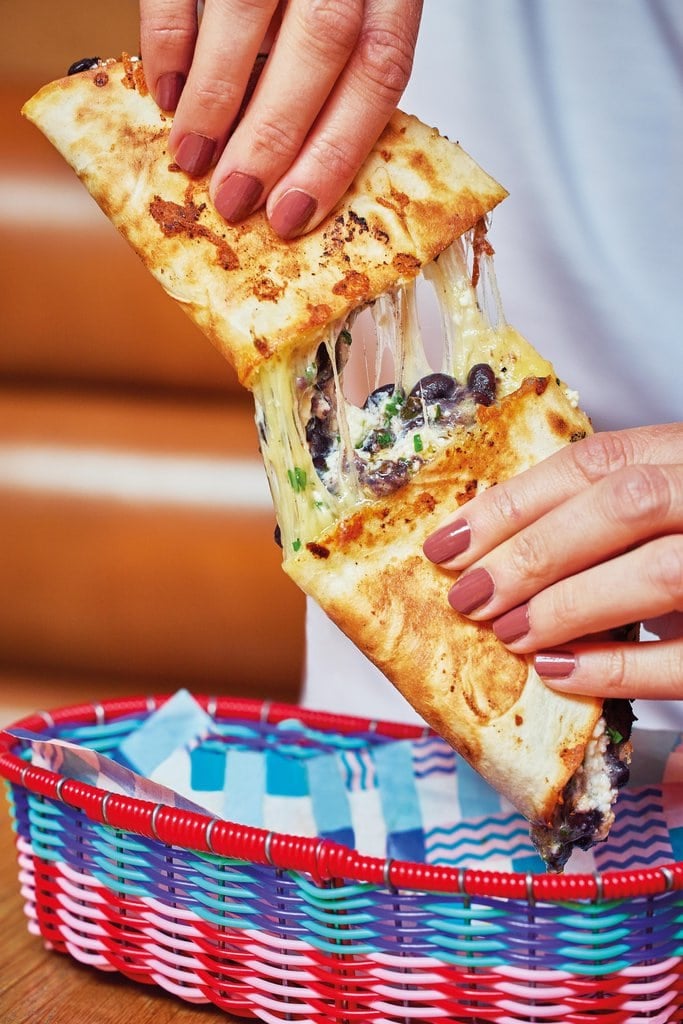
[0,693,683,902]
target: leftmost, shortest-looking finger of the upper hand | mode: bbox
[140,0,197,111]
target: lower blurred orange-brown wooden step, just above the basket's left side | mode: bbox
[0,389,304,694]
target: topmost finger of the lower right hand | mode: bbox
[424,423,683,569]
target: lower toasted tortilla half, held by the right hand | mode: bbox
[284,378,602,822]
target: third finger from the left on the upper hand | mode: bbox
[211,0,364,223]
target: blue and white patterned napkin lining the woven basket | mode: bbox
[116,691,683,871]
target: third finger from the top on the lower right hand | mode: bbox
[493,534,683,653]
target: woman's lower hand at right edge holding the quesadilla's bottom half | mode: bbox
[424,423,683,699]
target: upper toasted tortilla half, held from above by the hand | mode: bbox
[23,57,507,387]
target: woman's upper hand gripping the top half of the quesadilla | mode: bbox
[140,0,422,239]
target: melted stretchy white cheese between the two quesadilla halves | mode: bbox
[254,236,553,557]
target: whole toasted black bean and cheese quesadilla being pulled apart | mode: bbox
[24,55,630,870]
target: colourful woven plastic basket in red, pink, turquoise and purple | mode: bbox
[0,696,683,1024]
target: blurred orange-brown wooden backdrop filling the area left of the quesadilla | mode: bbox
[0,0,304,724]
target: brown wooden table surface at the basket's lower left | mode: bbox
[0,788,244,1024]
